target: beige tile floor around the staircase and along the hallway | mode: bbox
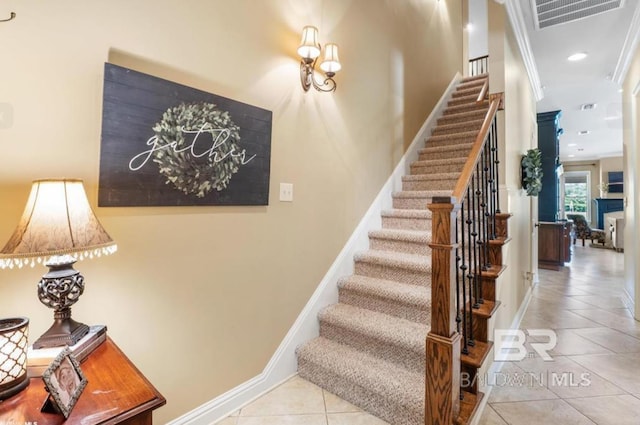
[217,243,640,425]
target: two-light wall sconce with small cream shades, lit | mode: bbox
[298,26,342,92]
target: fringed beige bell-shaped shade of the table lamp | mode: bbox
[0,179,117,268]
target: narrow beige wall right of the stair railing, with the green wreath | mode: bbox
[488,1,538,338]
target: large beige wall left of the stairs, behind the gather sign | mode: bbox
[0,0,462,423]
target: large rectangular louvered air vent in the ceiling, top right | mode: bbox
[531,0,625,29]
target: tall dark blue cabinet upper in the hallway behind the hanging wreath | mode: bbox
[537,111,562,222]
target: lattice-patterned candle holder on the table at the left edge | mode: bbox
[0,317,29,401]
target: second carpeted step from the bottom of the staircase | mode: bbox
[318,303,429,360]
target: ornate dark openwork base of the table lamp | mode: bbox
[33,256,89,349]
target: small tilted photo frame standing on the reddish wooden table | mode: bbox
[42,347,87,419]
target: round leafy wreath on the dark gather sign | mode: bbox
[153,102,241,198]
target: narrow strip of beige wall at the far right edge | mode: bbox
[622,45,640,314]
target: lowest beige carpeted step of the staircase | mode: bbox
[297,337,425,425]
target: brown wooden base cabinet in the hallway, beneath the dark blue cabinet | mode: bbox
[538,221,573,270]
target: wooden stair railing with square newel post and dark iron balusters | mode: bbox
[425,87,503,425]
